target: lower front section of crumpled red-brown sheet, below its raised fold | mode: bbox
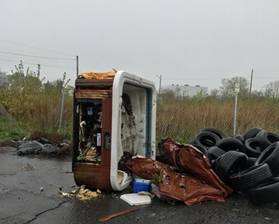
[128,158,230,205]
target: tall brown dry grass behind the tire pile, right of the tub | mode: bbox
[157,93,279,142]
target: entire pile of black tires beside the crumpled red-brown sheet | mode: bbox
[191,128,279,204]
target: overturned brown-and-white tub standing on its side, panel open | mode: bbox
[72,71,156,191]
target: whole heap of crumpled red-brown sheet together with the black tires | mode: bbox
[126,128,279,205]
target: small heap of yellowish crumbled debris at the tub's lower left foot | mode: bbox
[59,185,101,201]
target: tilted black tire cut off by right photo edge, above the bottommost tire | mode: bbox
[255,142,279,176]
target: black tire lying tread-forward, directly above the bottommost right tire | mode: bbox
[230,163,273,191]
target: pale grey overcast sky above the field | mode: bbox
[0,0,279,88]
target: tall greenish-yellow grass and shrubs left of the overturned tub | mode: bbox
[0,73,72,137]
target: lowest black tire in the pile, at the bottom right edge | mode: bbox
[247,177,279,204]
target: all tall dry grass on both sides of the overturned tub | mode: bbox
[0,73,279,142]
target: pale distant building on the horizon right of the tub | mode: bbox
[162,84,208,97]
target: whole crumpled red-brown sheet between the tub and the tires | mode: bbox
[126,138,232,205]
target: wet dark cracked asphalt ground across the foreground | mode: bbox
[0,147,279,224]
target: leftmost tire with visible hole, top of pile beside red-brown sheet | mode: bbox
[194,131,220,153]
